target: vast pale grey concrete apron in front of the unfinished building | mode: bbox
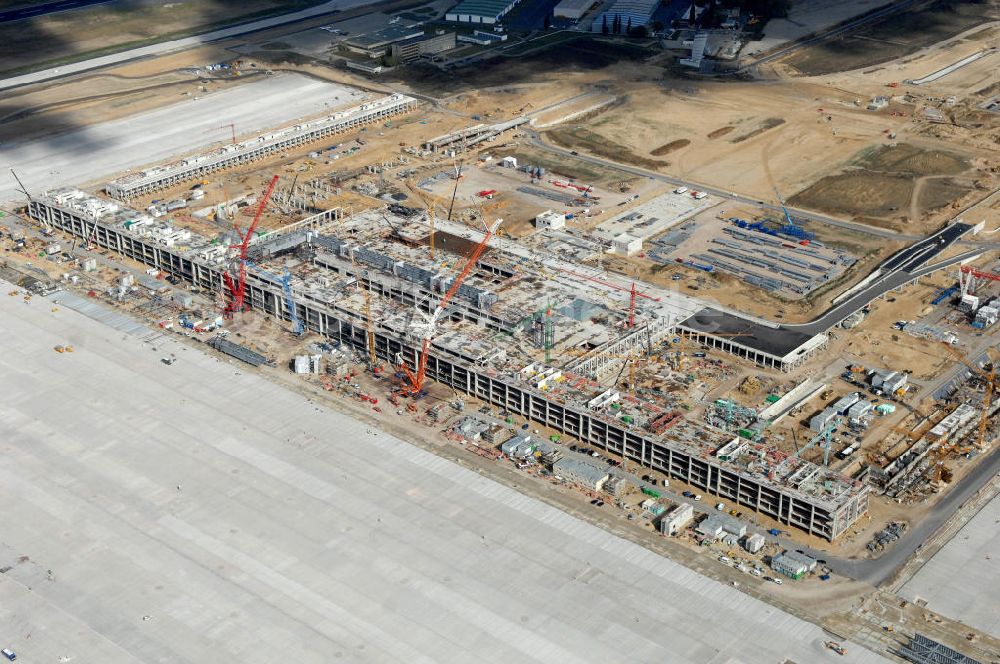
[0,284,885,664]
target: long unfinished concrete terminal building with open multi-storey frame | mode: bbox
[23,190,868,540]
